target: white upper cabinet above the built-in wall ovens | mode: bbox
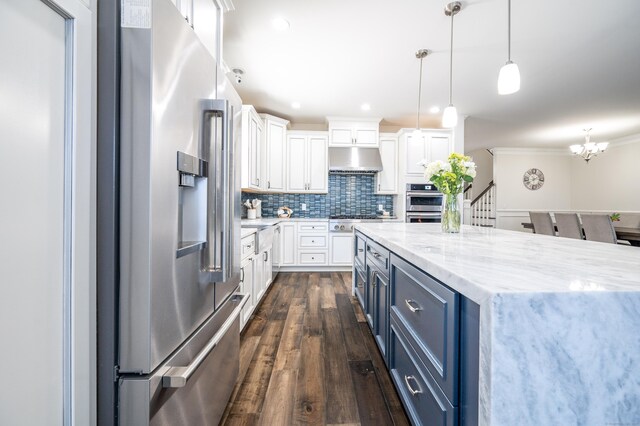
[403,131,453,176]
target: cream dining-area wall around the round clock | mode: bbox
[493,135,640,231]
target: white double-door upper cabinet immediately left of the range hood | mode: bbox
[286,132,329,193]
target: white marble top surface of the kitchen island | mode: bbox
[356,223,640,304]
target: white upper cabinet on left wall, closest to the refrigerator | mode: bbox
[241,105,266,190]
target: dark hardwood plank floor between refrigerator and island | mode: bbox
[221,272,409,426]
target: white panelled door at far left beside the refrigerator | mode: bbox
[0,0,95,425]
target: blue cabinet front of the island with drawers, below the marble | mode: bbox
[354,233,479,426]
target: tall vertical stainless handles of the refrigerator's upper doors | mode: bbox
[201,99,233,282]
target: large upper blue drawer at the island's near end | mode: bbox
[390,254,460,405]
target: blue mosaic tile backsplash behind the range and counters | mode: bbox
[242,174,393,218]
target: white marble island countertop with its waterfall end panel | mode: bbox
[354,224,640,425]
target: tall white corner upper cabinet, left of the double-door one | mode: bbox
[260,114,289,192]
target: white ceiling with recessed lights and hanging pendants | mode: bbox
[224,0,640,152]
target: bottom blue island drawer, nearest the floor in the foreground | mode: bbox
[389,319,458,426]
